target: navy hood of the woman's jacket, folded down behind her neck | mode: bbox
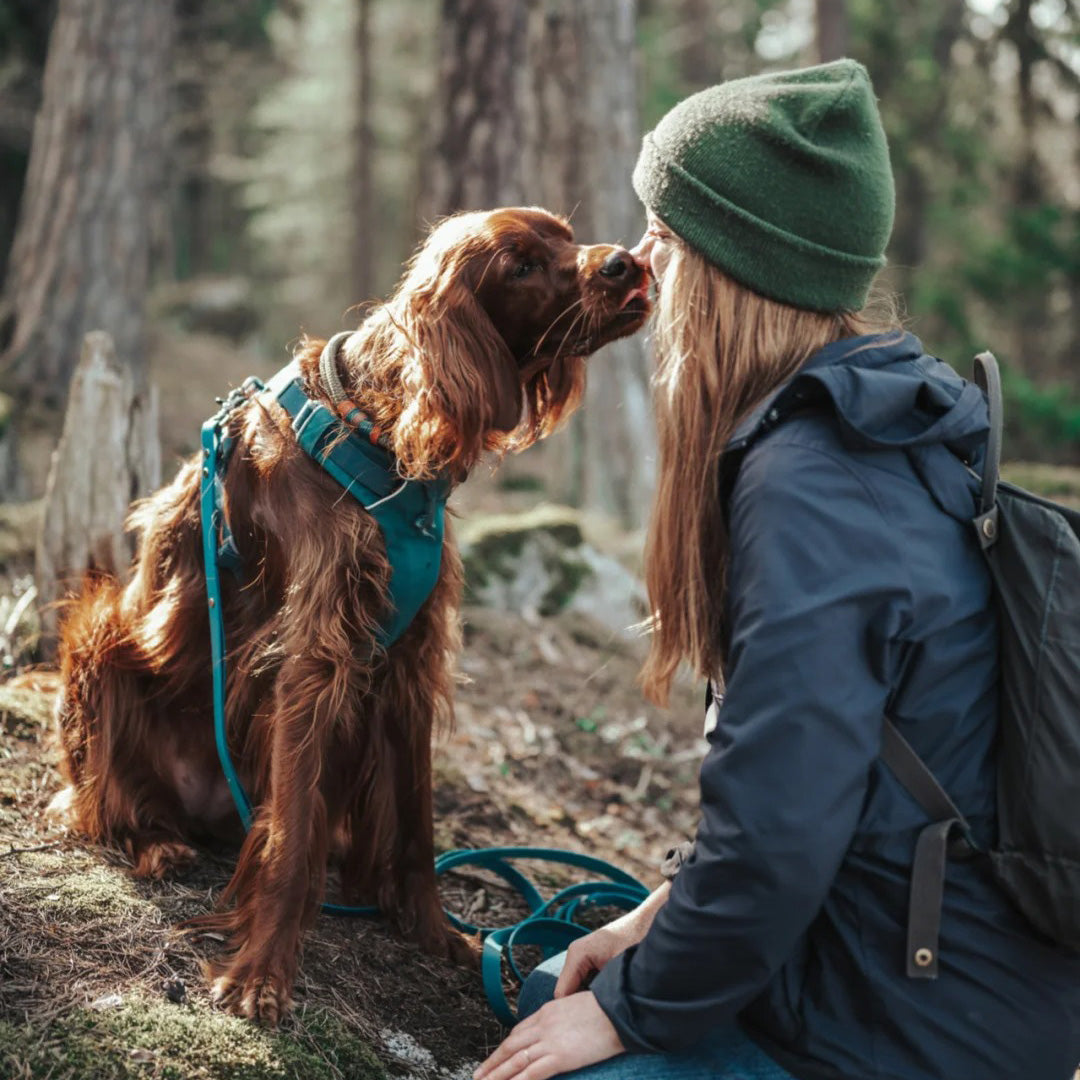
[728,332,989,460]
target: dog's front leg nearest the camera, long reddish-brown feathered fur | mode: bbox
[204,507,386,1025]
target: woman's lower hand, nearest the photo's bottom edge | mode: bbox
[473,990,625,1080]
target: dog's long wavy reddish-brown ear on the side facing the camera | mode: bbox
[400,275,524,468]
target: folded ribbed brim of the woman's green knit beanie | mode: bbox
[632,135,886,311]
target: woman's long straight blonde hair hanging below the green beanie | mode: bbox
[639,238,899,704]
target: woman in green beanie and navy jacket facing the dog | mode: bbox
[476,60,1080,1080]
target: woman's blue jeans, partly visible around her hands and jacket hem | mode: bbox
[517,953,794,1080]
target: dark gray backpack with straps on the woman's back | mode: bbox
[881,352,1080,978]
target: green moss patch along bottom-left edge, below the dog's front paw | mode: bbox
[0,999,386,1080]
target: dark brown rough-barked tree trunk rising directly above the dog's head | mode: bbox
[422,0,536,220]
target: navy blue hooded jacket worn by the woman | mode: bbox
[592,334,1080,1080]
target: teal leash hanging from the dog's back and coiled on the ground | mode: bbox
[200,378,649,1026]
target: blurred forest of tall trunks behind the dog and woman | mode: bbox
[0,0,1080,526]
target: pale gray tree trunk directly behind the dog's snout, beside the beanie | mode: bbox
[523,0,656,527]
